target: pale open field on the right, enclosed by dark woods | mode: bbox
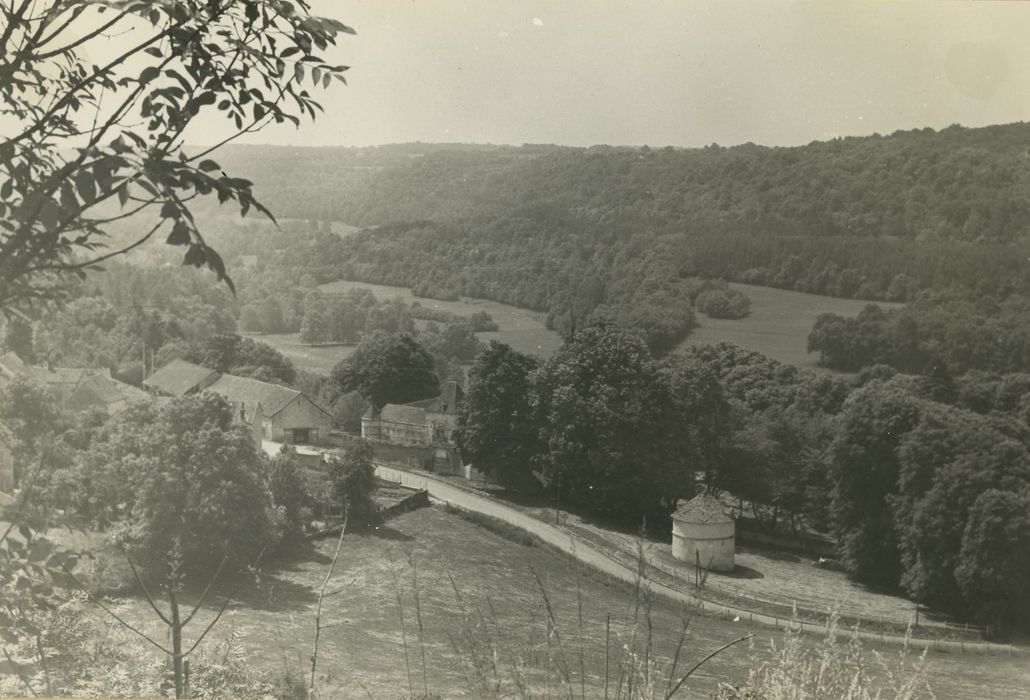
[680,283,902,370]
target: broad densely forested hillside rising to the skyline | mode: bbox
[215,124,1030,351]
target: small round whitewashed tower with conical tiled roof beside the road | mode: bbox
[673,493,735,571]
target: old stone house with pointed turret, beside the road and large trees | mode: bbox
[362,382,465,474]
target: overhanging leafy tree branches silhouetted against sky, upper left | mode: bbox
[0,0,353,314]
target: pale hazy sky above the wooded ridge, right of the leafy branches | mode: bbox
[209,0,1030,146]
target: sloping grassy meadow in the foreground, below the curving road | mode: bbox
[10,509,1028,699]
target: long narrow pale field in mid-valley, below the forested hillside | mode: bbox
[319,280,561,357]
